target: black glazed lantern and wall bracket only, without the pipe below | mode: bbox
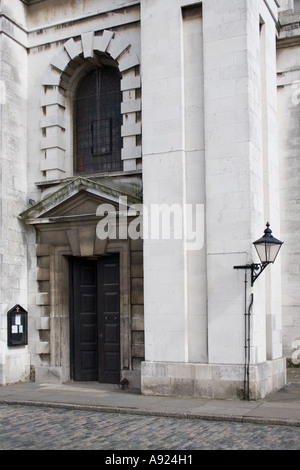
[234,222,283,286]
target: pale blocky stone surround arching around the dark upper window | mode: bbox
[41,30,141,181]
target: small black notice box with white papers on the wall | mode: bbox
[7,305,28,346]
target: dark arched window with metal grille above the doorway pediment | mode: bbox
[75,67,123,174]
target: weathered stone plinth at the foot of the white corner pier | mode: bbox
[141,358,286,400]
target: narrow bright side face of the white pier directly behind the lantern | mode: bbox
[259,2,282,360]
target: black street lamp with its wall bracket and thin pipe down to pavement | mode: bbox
[234,222,283,400]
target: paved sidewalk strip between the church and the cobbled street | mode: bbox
[0,368,300,426]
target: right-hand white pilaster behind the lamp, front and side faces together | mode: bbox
[204,1,282,364]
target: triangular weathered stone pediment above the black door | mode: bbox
[19,177,141,225]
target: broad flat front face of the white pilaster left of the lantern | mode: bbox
[203,1,252,364]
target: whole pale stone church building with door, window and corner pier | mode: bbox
[0,0,300,399]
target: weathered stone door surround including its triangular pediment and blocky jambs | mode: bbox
[19,177,144,384]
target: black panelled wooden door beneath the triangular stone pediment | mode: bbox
[71,255,120,383]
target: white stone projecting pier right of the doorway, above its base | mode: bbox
[142,0,282,398]
